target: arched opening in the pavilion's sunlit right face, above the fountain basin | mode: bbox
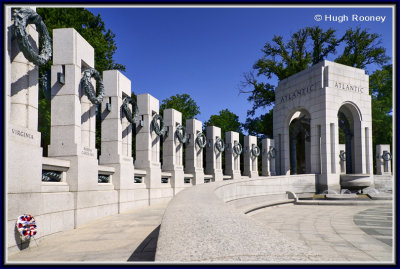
[337,103,362,174]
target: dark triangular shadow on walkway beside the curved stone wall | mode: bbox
[128,225,160,262]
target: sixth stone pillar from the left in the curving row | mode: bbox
[185,119,204,185]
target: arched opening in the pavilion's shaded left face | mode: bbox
[289,110,311,175]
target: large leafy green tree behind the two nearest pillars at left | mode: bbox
[36,8,125,156]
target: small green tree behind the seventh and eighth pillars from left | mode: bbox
[204,109,243,139]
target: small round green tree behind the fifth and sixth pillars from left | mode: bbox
[160,93,200,126]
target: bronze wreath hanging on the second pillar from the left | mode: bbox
[81,67,104,105]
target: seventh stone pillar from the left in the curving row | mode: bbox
[206,126,223,181]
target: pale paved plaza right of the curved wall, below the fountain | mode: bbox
[248,204,393,262]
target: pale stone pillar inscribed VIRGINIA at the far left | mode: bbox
[6,8,42,194]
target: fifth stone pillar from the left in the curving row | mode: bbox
[162,109,185,195]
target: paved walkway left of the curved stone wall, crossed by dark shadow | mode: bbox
[8,203,167,264]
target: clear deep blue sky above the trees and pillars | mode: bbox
[88,6,392,125]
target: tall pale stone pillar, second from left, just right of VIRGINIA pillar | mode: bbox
[49,28,118,227]
